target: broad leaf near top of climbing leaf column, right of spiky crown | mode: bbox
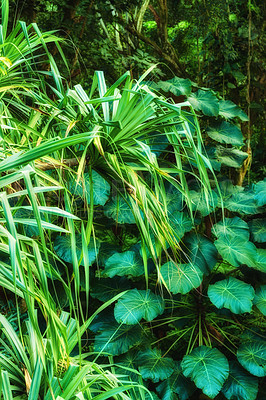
[188,89,219,117]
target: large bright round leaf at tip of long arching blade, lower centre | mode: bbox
[114,289,164,325]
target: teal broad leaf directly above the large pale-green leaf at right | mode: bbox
[212,217,249,241]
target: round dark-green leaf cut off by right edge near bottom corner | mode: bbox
[237,341,266,377]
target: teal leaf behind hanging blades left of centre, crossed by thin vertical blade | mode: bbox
[69,171,110,206]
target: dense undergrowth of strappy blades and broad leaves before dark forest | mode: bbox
[0,2,266,400]
